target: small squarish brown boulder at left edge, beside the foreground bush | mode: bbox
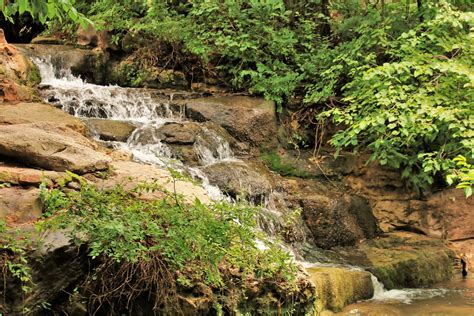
[0,186,43,224]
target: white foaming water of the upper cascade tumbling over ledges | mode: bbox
[33,57,231,200]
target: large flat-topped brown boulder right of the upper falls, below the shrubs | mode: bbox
[186,96,277,147]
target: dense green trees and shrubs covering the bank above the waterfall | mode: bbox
[1,0,474,194]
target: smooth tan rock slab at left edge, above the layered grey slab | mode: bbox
[0,102,87,135]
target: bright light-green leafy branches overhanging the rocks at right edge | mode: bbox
[322,4,474,193]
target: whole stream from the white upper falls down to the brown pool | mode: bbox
[34,58,474,315]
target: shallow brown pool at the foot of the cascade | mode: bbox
[336,275,474,316]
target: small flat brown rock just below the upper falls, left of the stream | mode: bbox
[85,119,136,142]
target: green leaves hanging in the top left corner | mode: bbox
[0,0,90,27]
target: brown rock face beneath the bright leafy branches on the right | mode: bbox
[345,161,474,241]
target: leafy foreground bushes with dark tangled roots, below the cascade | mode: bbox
[0,174,312,314]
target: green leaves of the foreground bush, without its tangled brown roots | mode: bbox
[41,177,295,287]
